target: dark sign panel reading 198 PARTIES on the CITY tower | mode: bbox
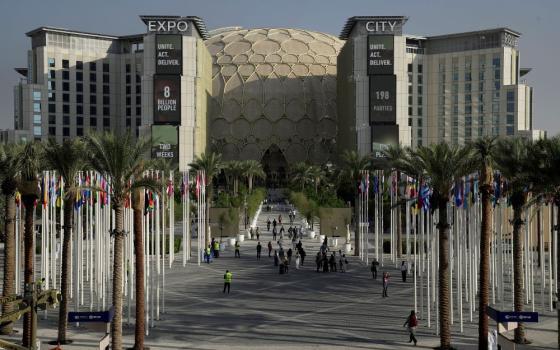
[369,75,397,124]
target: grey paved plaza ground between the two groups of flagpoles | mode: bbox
[2,204,556,350]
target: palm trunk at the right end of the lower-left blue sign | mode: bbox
[111,204,124,350]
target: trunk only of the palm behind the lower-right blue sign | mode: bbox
[512,200,525,344]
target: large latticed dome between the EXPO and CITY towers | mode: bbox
[206,27,344,164]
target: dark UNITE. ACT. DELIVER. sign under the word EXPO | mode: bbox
[156,34,183,74]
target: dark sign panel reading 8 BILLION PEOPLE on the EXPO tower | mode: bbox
[154,75,181,125]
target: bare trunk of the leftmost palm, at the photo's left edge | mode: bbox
[0,192,16,335]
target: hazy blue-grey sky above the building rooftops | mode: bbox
[0,0,560,135]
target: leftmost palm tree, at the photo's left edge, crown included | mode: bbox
[0,144,21,335]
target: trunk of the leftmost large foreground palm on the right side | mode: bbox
[438,200,451,350]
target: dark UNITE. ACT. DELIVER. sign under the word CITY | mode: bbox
[367,35,394,75]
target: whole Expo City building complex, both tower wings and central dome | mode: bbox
[9,16,544,170]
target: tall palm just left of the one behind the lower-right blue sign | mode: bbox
[472,137,501,350]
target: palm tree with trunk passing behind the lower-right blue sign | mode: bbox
[494,138,534,344]
